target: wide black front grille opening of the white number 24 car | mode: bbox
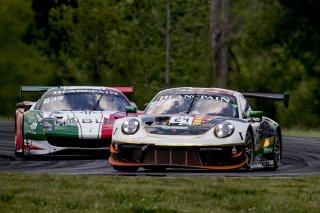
[117,143,244,166]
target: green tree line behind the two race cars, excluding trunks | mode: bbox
[0,0,320,128]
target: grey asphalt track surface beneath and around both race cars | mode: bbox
[0,121,320,177]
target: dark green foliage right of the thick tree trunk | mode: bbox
[229,0,320,127]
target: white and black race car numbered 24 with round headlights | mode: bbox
[109,87,288,171]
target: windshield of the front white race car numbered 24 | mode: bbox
[144,93,238,117]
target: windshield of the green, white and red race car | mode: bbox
[40,91,129,112]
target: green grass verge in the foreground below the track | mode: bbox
[0,173,320,212]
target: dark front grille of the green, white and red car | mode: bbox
[48,137,111,148]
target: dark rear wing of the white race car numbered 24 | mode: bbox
[241,92,289,108]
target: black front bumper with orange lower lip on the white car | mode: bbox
[109,141,246,169]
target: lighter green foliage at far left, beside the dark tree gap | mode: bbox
[0,0,55,117]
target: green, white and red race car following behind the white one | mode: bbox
[15,86,135,156]
